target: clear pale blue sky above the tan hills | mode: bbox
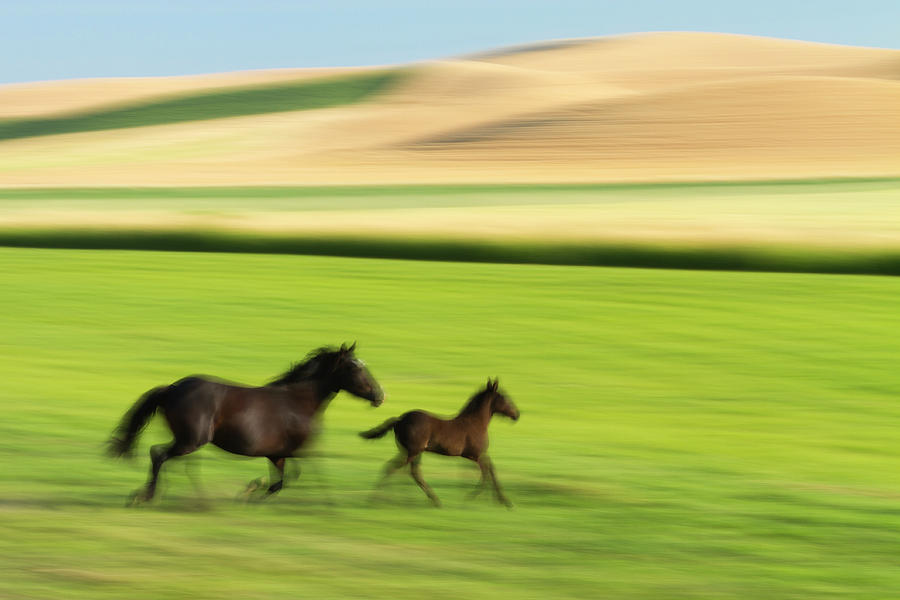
[0,0,900,83]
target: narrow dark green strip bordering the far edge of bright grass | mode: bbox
[0,229,900,275]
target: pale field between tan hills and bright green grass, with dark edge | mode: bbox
[0,179,900,275]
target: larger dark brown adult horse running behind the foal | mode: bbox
[109,344,384,502]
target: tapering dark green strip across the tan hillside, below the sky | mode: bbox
[0,71,400,140]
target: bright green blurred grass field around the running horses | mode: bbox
[0,248,900,600]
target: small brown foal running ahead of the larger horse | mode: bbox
[359,379,519,506]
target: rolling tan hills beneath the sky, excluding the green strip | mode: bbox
[0,33,900,185]
